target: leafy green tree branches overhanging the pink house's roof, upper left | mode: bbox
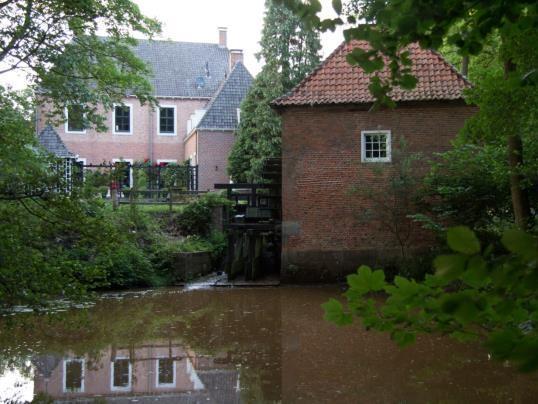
[0,0,160,129]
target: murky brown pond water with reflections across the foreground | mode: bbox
[0,287,538,403]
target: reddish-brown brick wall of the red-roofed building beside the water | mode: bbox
[282,103,474,281]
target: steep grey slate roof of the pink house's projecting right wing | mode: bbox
[197,62,253,130]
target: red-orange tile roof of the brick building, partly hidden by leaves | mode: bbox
[273,41,471,106]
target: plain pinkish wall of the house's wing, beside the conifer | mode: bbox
[194,131,235,191]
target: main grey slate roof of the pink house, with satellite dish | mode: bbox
[134,39,229,98]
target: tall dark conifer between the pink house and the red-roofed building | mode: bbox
[229,0,321,182]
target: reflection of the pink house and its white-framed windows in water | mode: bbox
[33,341,240,403]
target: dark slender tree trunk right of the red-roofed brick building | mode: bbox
[504,60,531,229]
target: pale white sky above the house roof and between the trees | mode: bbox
[0,0,343,89]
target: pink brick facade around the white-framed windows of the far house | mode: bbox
[38,98,207,163]
